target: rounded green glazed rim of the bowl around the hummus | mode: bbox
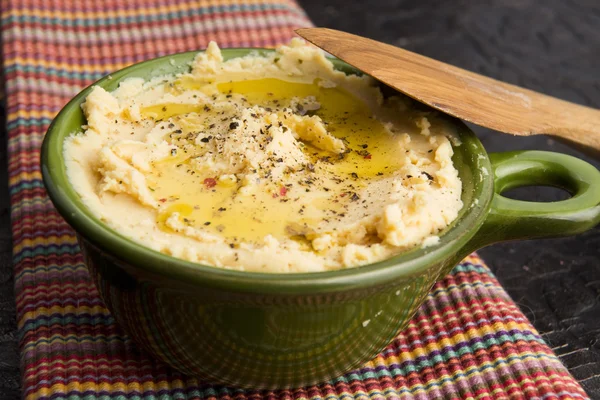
[40,48,493,294]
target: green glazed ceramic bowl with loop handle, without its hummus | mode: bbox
[41,49,600,388]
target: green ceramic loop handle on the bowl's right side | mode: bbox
[465,151,600,252]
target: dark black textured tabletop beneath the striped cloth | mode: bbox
[0,0,600,399]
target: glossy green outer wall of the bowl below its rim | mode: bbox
[79,237,440,388]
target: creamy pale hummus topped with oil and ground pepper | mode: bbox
[64,40,462,272]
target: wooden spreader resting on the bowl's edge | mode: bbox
[296,28,600,157]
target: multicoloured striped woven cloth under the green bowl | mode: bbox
[0,0,587,400]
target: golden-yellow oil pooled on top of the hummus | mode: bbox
[142,78,405,242]
